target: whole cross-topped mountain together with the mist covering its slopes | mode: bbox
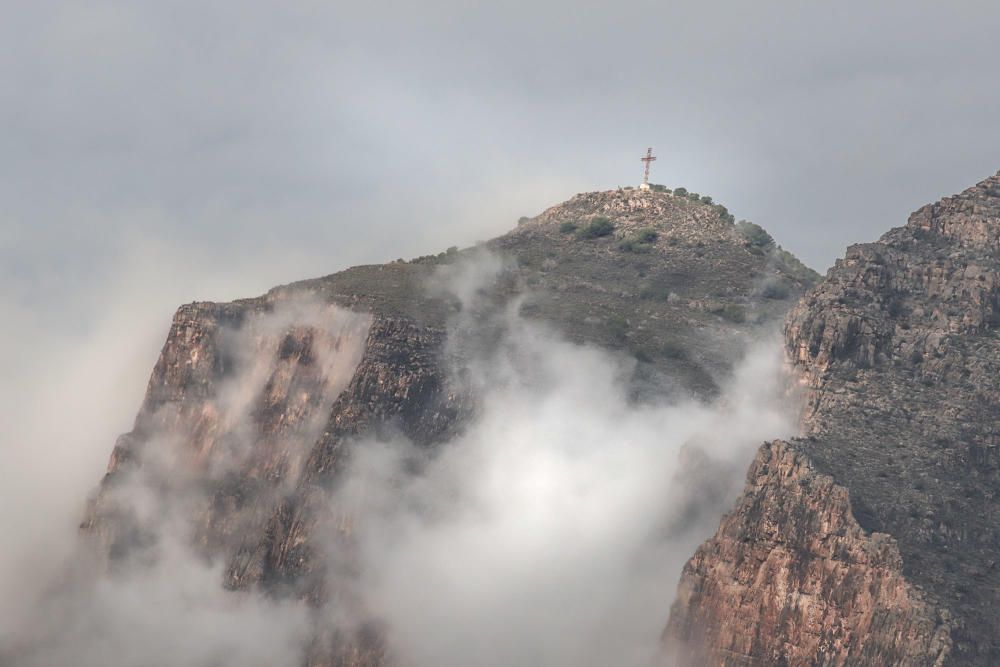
[3,189,816,665]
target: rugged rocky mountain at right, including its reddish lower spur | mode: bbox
[665,175,1000,665]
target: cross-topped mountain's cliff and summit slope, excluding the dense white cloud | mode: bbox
[76,190,812,667]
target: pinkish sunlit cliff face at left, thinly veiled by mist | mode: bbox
[83,302,371,560]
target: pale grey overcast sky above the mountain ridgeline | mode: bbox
[0,0,1000,414]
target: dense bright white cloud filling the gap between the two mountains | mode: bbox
[334,257,794,667]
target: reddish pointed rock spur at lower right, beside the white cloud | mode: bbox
[665,441,950,665]
